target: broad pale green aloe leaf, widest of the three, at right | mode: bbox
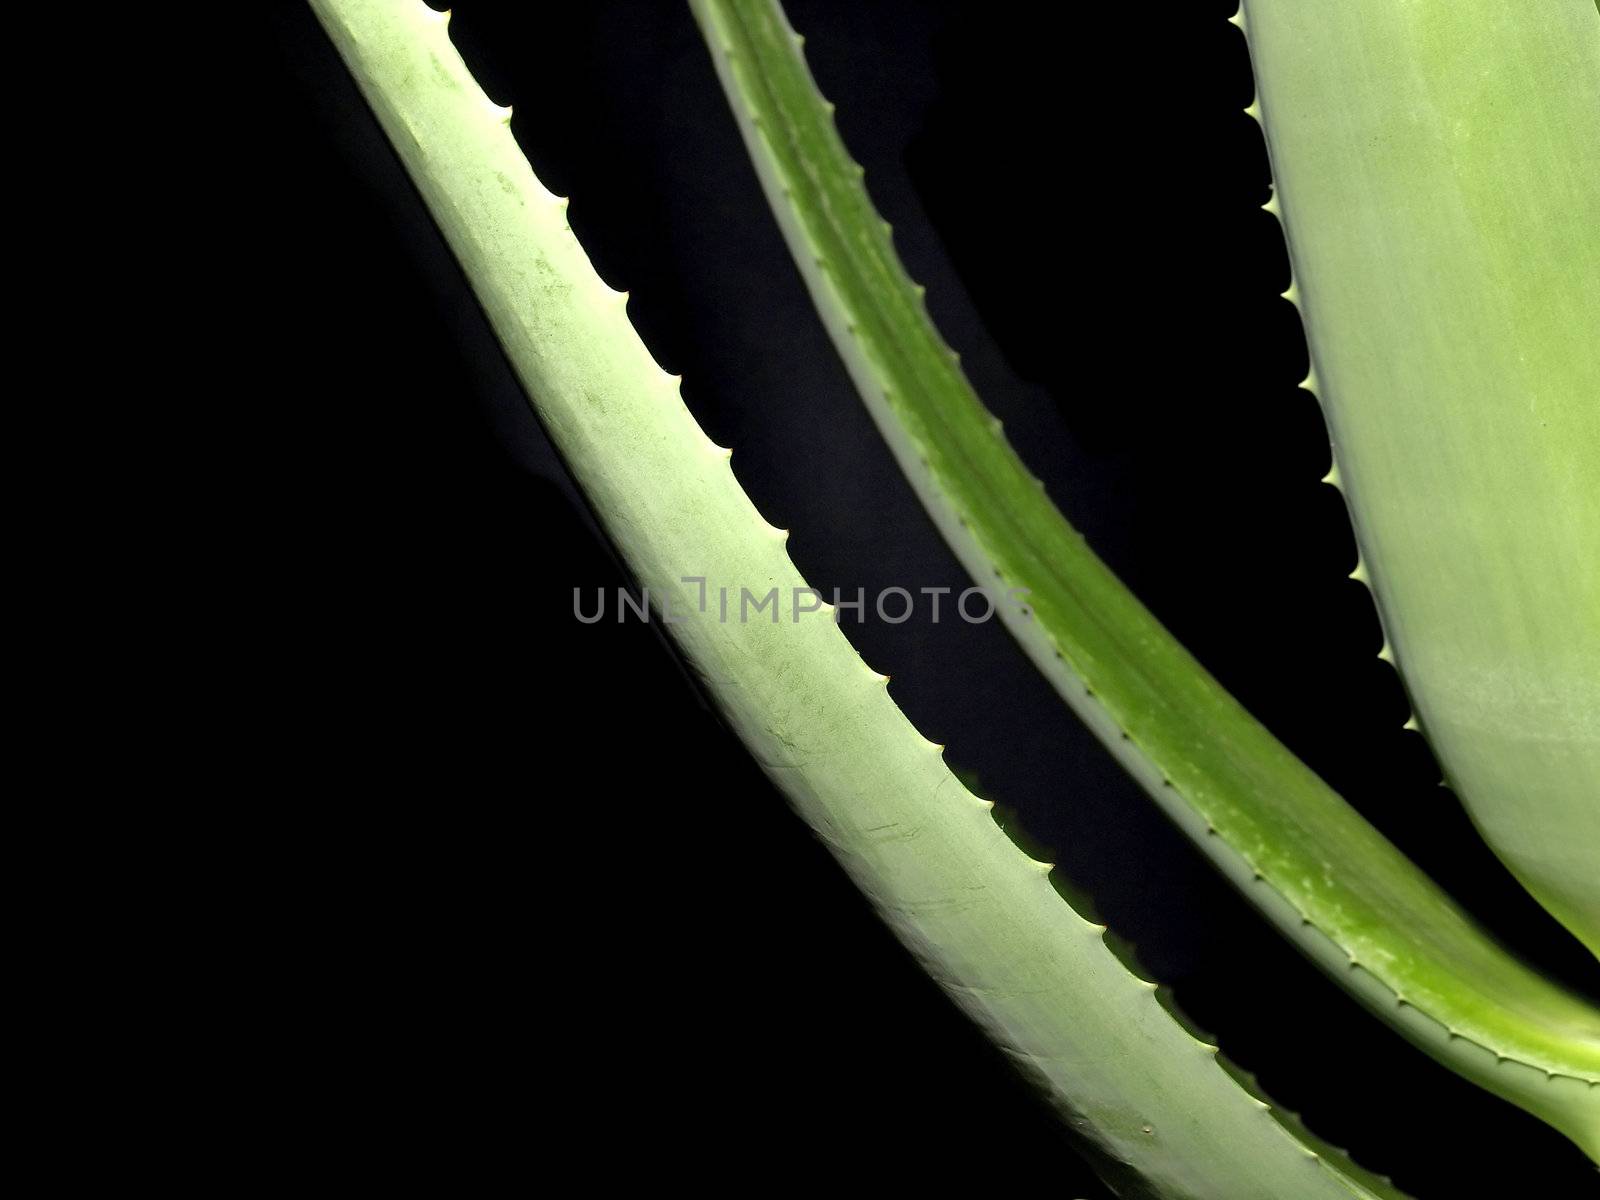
[1242,0,1600,954]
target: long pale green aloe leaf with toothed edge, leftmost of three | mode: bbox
[312,0,1398,1200]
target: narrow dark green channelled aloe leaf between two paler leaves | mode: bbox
[691,0,1600,1158]
